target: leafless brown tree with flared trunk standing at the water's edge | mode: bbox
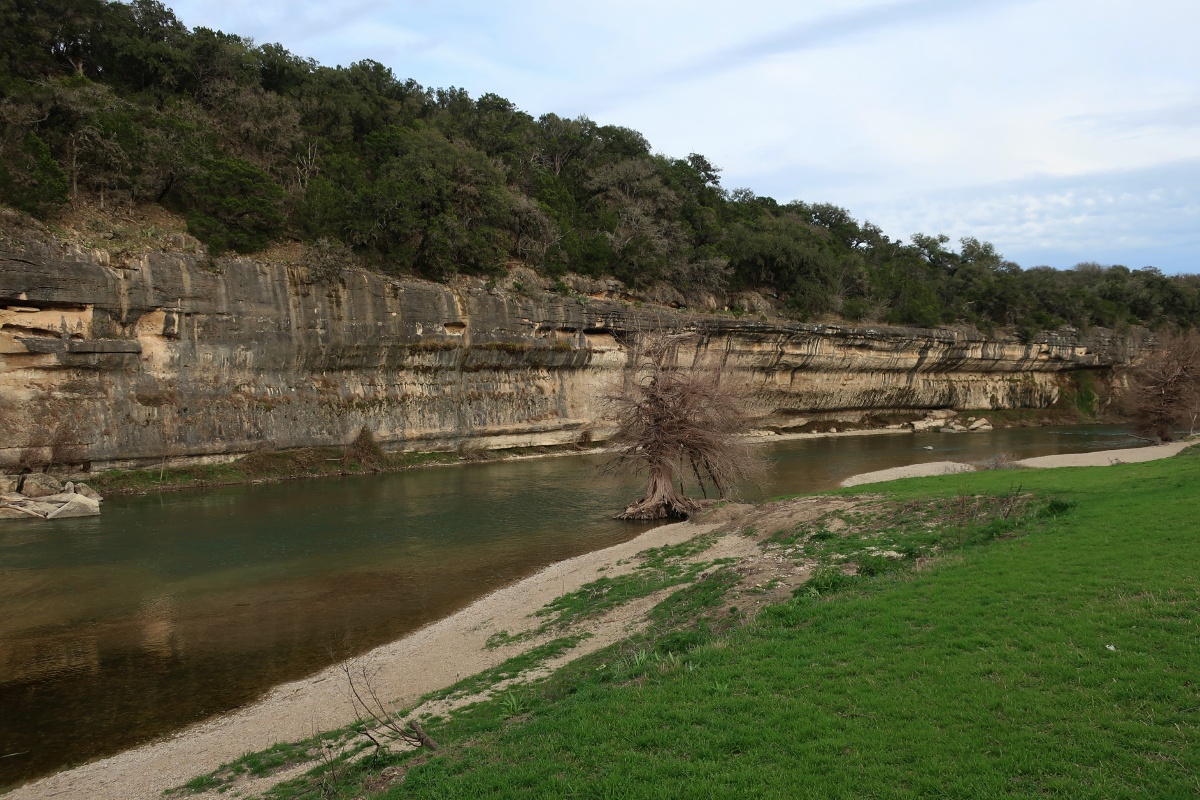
[605,333,760,519]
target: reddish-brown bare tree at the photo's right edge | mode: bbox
[1122,331,1200,441]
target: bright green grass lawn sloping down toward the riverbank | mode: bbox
[182,449,1200,798]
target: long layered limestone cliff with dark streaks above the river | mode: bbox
[0,243,1141,473]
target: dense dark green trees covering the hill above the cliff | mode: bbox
[0,0,1200,331]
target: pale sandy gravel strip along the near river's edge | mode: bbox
[8,432,1200,800]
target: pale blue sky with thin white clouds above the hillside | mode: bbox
[168,0,1200,273]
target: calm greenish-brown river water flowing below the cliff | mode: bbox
[0,426,1142,787]
